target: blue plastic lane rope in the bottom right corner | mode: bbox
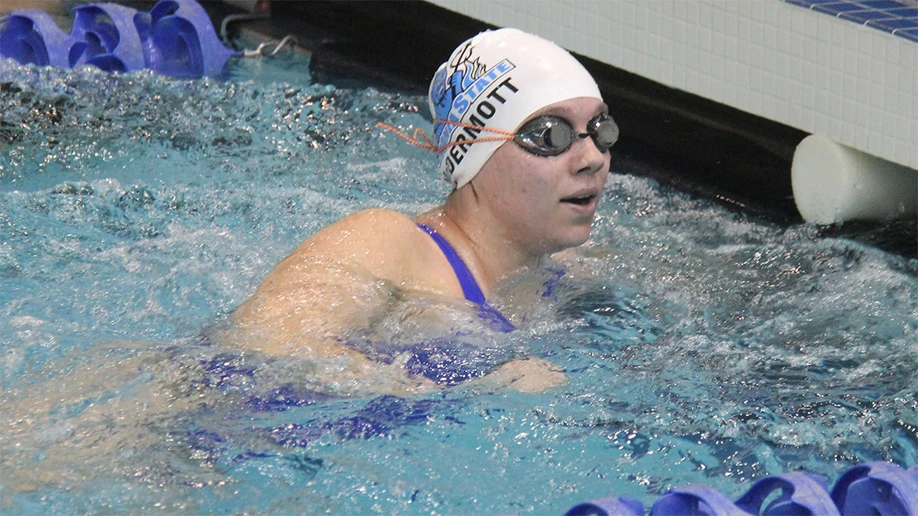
[565,462,918,516]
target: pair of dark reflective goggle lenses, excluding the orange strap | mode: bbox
[513,113,618,156]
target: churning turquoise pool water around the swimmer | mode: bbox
[0,47,918,514]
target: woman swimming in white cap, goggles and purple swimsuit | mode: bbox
[223,29,618,394]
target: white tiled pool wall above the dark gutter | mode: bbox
[428,0,918,169]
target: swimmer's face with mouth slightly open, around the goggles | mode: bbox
[472,97,610,254]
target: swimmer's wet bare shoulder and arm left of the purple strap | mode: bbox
[218,210,446,395]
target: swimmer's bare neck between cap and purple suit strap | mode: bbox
[418,186,544,296]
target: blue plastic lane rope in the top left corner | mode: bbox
[0,0,242,77]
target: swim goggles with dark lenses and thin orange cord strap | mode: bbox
[376,113,618,157]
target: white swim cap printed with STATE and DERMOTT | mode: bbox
[428,29,602,188]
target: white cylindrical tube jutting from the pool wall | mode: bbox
[791,134,918,224]
